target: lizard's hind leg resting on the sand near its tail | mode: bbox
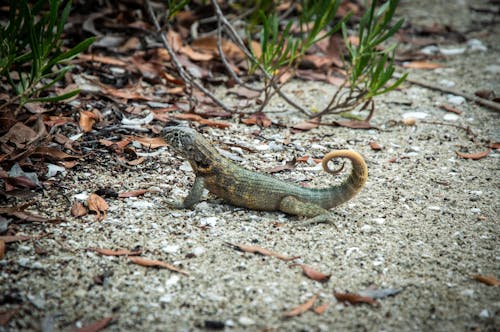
[279,196,333,226]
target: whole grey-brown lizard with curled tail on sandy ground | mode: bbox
[164,126,368,224]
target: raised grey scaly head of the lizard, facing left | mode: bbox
[164,126,217,173]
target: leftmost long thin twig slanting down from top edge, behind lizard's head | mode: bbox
[144,0,233,112]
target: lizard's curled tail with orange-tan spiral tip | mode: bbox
[322,150,368,208]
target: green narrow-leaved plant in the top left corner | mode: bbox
[0,0,95,107]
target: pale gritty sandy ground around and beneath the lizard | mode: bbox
[0,1,500,331]
